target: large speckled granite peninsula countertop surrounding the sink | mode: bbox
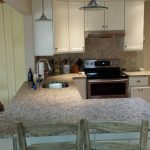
[0,74,150,133]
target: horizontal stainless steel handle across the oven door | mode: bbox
[88,79,128,83]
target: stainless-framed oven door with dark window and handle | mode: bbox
[87,79,128,98]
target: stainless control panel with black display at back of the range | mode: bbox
[84,59,120,68]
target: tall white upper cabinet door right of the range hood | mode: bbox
[124,2,144,51]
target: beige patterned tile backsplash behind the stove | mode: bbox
[36,38,144,70]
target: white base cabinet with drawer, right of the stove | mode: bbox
[129,76,150,102]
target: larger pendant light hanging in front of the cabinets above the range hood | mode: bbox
[79,0,108,11]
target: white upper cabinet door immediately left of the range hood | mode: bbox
[69,2,84,52]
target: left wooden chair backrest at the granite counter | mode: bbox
[17,121,84,150]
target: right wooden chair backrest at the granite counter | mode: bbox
[84,119,148,150]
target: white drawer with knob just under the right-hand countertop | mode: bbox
[129,76,148,86]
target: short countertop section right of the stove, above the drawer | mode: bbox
[124,71,150,76]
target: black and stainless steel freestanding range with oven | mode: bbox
[84,60,128,98]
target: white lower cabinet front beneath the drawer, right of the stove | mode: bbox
[130,87,150,102]
